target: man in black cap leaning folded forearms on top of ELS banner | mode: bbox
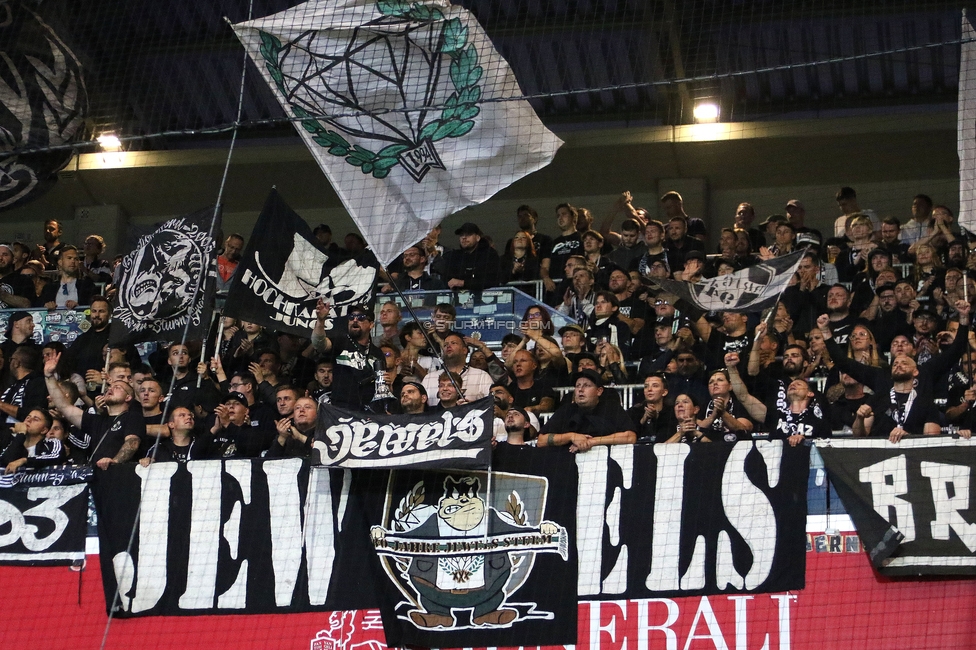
[538,370,637,453]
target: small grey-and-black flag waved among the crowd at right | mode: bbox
[659,251,805,312]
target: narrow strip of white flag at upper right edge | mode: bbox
[956,9,976,233]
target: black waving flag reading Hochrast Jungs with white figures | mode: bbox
[223,190,376,336]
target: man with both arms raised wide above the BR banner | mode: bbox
[817,300,970,442]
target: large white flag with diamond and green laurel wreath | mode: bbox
[234,0,562,265]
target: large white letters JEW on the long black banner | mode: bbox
[112,458,352,614]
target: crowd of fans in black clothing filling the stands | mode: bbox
[0,188,976,473]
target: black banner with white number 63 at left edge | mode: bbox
[0,467,91,565]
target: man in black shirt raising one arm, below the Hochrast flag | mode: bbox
[312,299,385,411]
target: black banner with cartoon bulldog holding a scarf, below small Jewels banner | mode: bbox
[370,444,577,648]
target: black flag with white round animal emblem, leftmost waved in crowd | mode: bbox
[109,207,220,343]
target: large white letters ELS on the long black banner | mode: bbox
[576,440,783,597]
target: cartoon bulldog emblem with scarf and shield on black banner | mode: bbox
[370,472,568,629]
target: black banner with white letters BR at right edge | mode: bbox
[819,437,976,576]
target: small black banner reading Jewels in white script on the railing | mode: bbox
[312,397,495,469]
